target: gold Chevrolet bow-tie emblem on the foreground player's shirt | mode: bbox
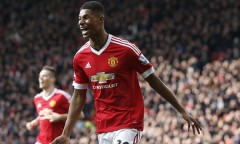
[91,72,115,83]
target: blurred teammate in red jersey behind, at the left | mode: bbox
[26,66,71,144]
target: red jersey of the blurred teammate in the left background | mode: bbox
[34,88,71,144]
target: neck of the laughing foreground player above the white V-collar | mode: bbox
[89,31,108,51]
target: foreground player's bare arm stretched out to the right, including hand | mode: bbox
[145,73,202,134]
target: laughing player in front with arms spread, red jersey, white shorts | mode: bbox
[52,1,202,144]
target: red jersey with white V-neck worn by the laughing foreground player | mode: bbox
[73,35,154,133]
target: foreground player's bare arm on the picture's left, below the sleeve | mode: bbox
[52,89,87,144]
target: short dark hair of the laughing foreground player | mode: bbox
[80,1,104,14]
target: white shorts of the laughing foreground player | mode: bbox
[98,129,142,144]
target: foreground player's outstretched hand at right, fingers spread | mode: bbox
[182,113,202,135]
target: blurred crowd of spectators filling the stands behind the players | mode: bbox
[0,0,240,144]
